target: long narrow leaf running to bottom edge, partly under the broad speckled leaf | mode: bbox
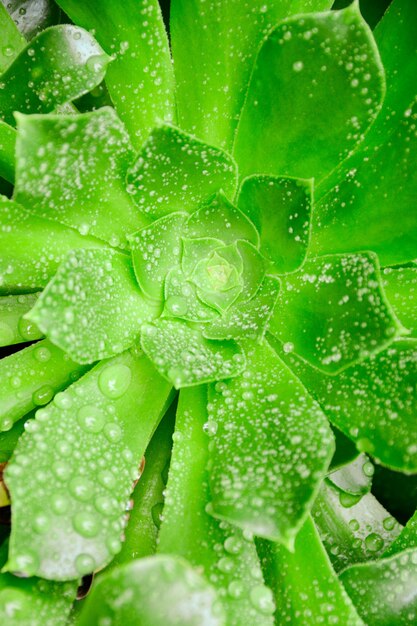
[158,387,274,626]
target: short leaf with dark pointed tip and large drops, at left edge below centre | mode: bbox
[0,339,88,431]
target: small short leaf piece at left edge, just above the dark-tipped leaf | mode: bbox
[0,293,42,346]
